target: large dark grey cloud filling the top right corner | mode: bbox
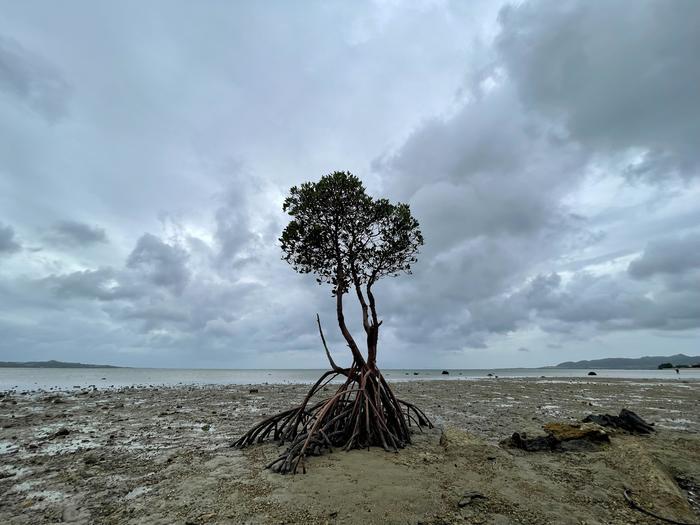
[497,0,700,180]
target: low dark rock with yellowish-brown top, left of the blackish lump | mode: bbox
[501,423,610,452]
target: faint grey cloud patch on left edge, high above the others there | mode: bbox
[0,35,70,122]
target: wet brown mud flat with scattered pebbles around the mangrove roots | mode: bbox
[0,378,700,525]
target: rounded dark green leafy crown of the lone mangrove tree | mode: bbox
[280,171,423,294]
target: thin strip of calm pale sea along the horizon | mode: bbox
[0,368,700,390]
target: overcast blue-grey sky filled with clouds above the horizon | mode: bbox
[0,0,700,368]
